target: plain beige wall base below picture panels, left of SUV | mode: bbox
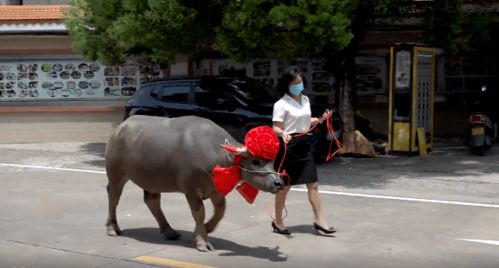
[0,101,124,144]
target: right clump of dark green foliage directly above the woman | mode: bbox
[216,0,378,61]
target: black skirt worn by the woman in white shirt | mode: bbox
[274,135,318,185]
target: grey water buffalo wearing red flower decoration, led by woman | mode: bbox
[105,115,283,251]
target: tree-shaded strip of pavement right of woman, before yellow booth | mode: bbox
[318,146,499,189]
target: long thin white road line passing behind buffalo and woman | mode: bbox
[0,163,499,208]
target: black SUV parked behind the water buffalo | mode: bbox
[125,76,276,141]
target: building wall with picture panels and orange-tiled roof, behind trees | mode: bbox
[0,0,499,138]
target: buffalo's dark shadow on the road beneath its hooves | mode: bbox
[122,228,287,262]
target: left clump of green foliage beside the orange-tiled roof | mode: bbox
[65,0,223,63]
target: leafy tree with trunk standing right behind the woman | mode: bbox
[216,0,399,154]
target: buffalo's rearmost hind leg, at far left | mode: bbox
[106,179,126,235]
